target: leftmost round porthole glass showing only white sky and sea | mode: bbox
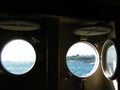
[1,39,36,75]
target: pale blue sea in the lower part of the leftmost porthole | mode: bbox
[2,61,34,75]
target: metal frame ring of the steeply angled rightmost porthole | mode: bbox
[101,38,120,80]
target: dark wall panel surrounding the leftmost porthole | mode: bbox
[0,17,47,90]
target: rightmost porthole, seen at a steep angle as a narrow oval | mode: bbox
[101,39,118,79]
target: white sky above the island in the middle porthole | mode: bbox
[67,42,96,56]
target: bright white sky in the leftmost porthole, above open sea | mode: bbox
[1,39,36,62]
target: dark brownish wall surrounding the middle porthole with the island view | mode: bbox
[58,17,115,90]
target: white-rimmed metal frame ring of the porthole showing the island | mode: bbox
[66,41,100,79]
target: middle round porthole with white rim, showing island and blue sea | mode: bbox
[66,41,99,78]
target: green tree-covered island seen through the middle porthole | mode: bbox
[66,55,95,63]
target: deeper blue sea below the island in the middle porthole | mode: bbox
[67,60,95,77]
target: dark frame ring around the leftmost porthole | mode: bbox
[0,36,37,77]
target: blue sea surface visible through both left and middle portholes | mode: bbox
[2,60,94,77]
